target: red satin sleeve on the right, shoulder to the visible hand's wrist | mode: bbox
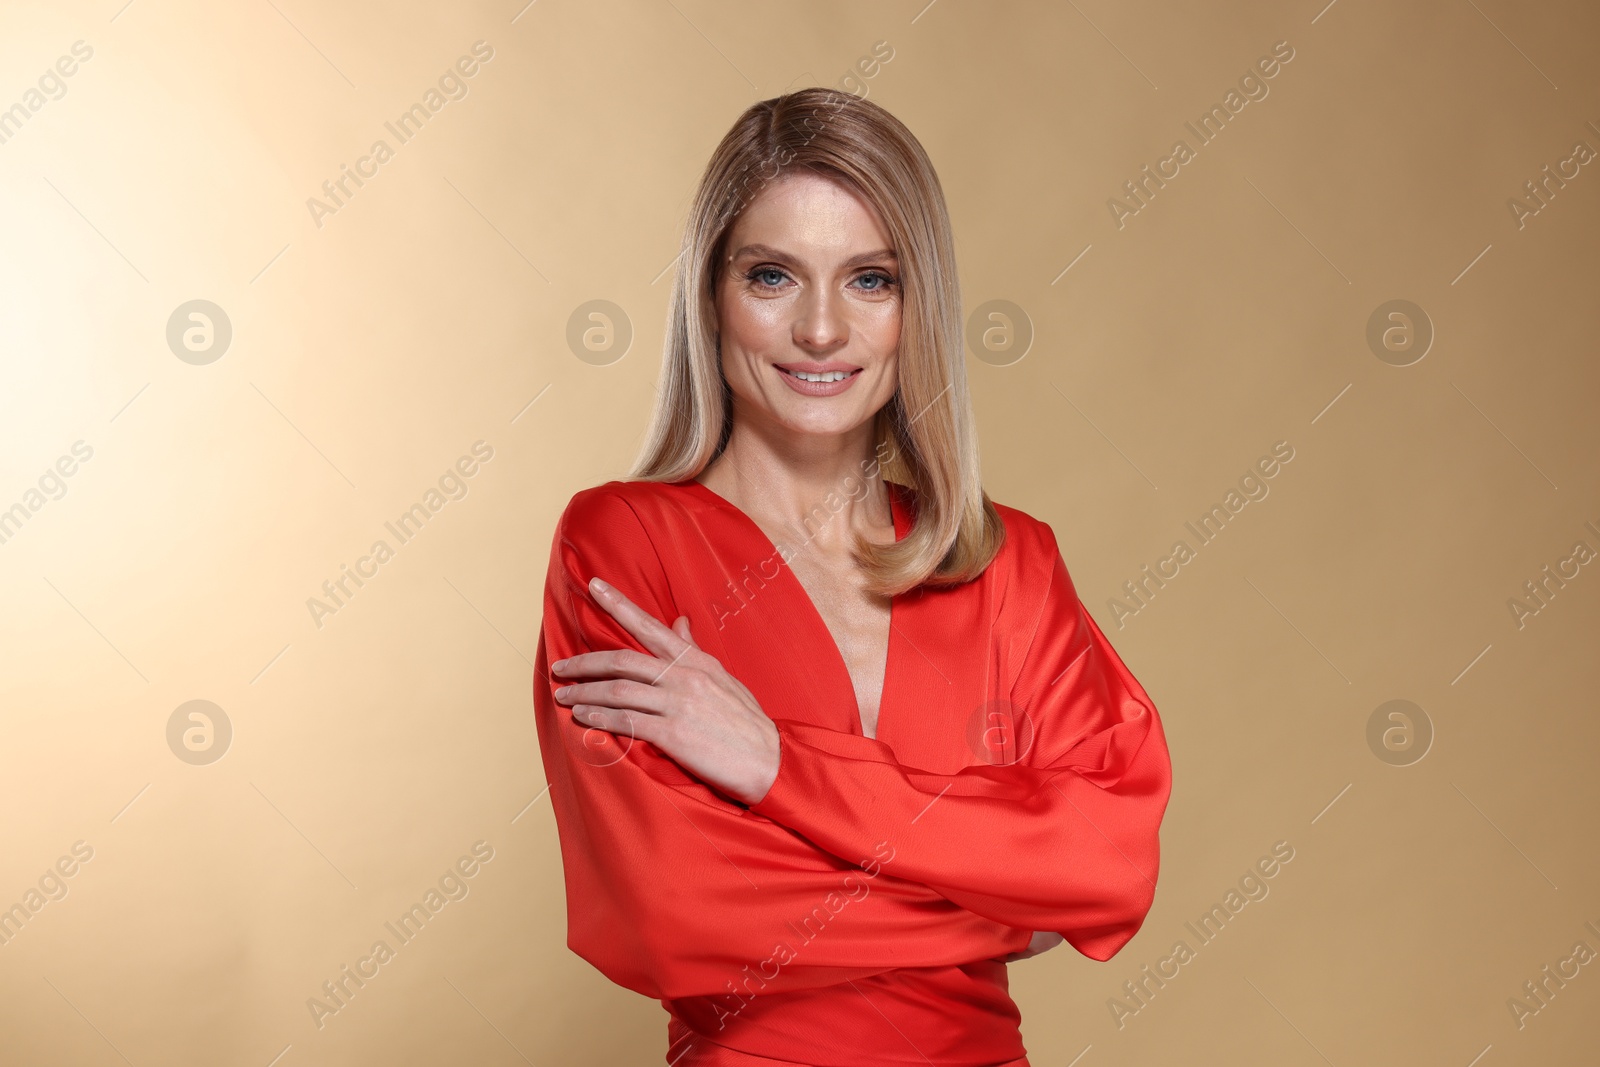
[750,523,1171,960]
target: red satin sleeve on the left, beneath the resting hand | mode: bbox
[533,486,1027,998]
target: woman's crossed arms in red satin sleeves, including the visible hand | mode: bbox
[534,501,1170,997]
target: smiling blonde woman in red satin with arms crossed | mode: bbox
[534,90,1171,1067]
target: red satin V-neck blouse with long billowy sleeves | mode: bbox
[533,480,1171,1067]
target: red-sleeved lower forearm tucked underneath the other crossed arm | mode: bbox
[536,668,1029,998]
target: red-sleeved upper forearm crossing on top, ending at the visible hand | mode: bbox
[752,694,1170,958]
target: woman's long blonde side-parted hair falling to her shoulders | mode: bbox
[629,88,1005,595]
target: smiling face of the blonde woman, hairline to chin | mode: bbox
[717,171,901,435]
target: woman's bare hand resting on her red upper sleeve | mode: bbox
[550,577,779,805]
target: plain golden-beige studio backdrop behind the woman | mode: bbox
[0,0,1600,1067]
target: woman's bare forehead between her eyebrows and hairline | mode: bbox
[728,171,893,258]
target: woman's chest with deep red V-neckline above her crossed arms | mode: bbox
[678,483,1024,773]
